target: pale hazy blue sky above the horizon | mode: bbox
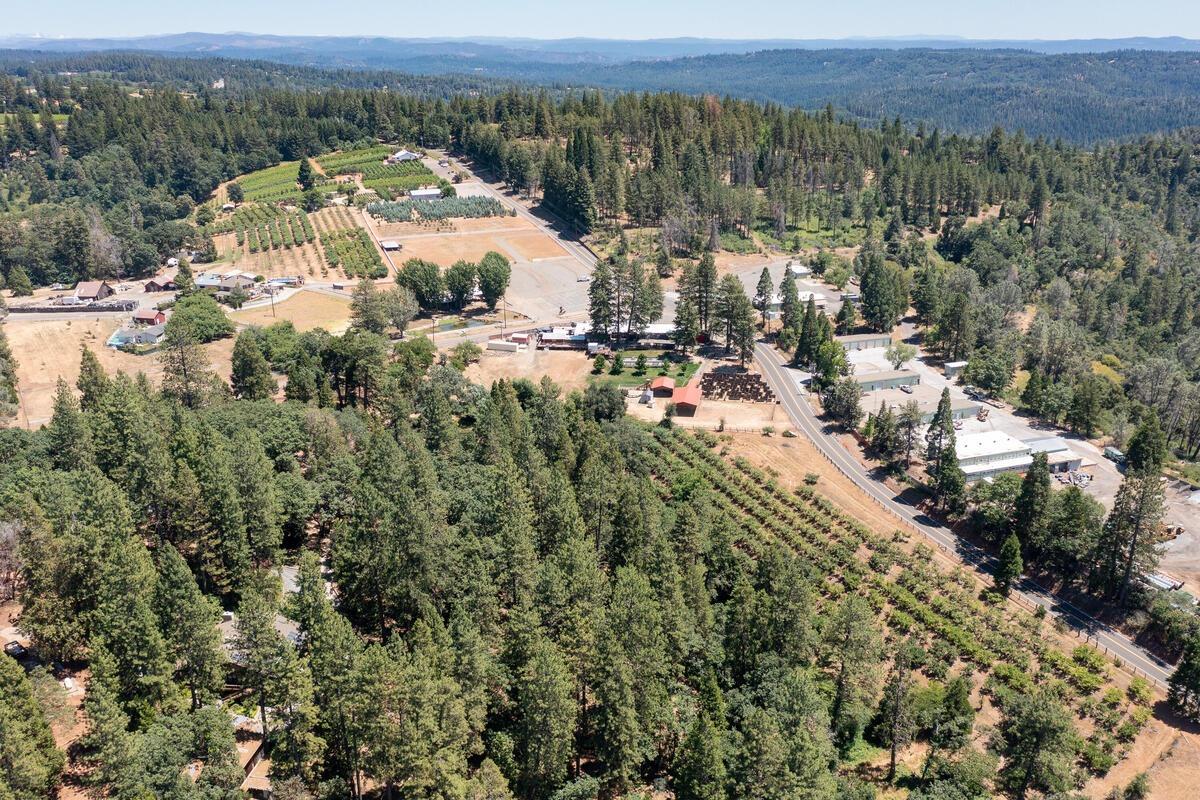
[7,0,1200,38]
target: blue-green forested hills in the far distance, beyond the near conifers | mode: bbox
[11,42,1200,145]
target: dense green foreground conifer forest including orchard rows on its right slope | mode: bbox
[0,324,1171,800]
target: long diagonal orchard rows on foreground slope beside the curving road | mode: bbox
[648,429,1147,774]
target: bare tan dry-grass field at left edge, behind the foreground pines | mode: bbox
[5,317,233,428]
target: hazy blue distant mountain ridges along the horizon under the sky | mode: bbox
[0,34,1200,144]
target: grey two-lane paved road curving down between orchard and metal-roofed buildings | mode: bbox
[755,343,1174,686]
